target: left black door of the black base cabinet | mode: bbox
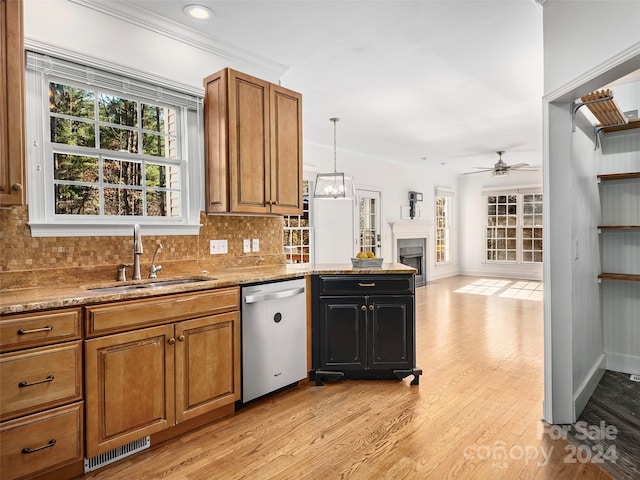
[320,297,367,370]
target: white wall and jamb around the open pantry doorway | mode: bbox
[543,0,640,423]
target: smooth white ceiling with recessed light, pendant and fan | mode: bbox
[82,0,543,173]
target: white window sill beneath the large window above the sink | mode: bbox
[29,222,201,237]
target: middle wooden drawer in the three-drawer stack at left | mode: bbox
[0,341,82,420]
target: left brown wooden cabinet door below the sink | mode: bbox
[85,325,176,457]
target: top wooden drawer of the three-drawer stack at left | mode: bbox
[0,308,82,352]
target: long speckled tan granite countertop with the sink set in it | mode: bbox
[0,263,416,315]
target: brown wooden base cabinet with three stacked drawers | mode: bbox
[0,308,84,480]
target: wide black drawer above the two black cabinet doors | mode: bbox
[318,275,415,295]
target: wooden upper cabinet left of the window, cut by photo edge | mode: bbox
[0,0,25,206]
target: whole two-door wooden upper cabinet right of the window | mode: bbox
[204,68,302,215]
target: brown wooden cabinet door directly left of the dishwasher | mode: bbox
[176,312,240,422]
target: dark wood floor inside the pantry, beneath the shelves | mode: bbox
[569,371,640,480]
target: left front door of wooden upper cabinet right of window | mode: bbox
[228,70,271,213]
